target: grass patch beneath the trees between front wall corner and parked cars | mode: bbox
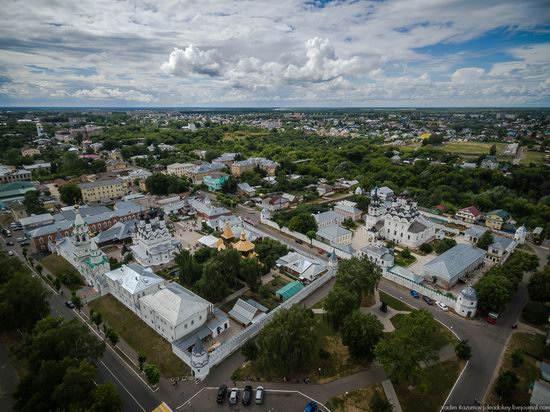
[232,315,370,384]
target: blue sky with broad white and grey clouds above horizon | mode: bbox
[0,0,550,107]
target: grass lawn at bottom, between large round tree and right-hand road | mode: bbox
[394,360,464,412]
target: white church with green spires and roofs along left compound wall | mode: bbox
[48,207,111,291]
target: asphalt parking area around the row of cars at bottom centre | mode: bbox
[178,388,328,412]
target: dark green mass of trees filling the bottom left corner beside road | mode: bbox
[0,251,121,412]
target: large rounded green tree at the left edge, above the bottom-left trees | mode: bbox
[0,266,50,330]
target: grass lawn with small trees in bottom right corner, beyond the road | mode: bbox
[487,332,544,405]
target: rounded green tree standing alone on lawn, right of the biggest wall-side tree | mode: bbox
[340,310,384,360]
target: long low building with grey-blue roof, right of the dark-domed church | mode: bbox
[422,244,485,289]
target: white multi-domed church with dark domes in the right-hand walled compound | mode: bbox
[363,188,435,249]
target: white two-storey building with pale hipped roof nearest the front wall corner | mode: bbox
[139,282,214,342]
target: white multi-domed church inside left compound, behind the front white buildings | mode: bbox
[130,215,180,267]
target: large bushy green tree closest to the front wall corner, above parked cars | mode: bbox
[256,305,319,376]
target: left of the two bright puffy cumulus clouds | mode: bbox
[161,44,222,77]
